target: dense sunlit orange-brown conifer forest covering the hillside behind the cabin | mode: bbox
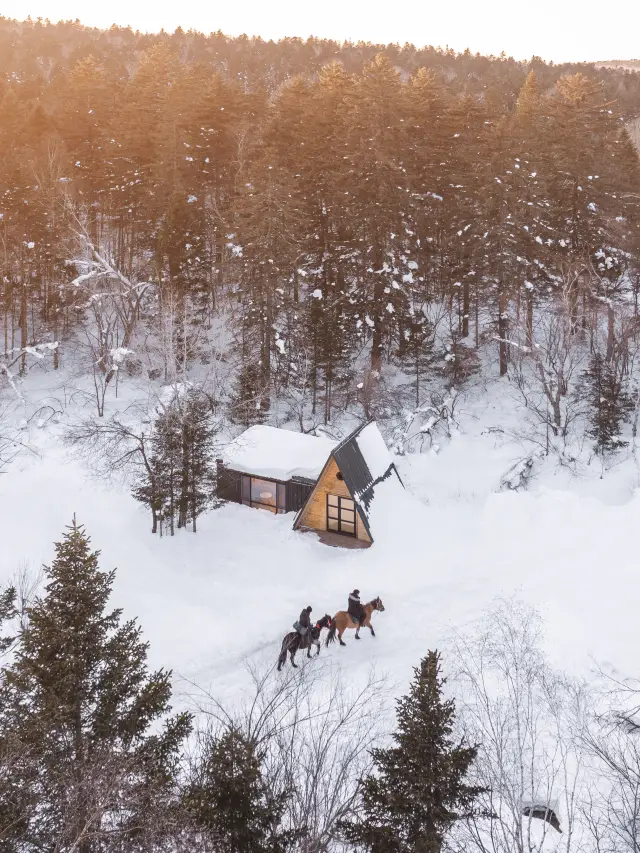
[0,13,640,460]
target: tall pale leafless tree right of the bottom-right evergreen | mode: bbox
[453,601,585,853]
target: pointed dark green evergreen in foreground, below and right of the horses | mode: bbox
[343,652,482,853]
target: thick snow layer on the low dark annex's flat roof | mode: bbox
[222,425,336,481]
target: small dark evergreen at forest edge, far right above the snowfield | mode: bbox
[584,352,633,454]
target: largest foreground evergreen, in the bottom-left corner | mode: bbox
[0,518,191,853]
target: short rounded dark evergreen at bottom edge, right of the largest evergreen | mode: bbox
[185,728,300,853]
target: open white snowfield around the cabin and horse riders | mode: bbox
[0,366,640,712]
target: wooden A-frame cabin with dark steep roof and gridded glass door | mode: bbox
[293,421,402,547]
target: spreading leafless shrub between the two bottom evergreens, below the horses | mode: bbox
[189,662,388,853]
